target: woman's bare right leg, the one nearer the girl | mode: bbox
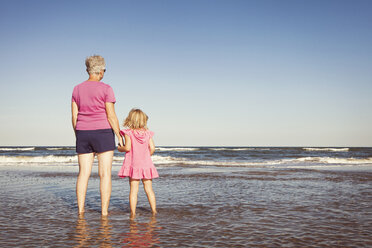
[97,151,114,215]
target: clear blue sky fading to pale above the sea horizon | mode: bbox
[0,0,372,146]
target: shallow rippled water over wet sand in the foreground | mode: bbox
[0,166,372,247]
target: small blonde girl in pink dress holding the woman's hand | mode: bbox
[118,109,159,218]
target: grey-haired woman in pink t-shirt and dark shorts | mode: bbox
[71,55,123,215]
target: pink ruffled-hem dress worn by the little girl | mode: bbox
[118,129,159,179]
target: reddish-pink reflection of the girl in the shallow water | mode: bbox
[122,216,159,247]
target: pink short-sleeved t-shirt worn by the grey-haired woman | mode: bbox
[72,81,116,130]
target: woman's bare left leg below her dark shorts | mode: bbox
[76,153,94,214]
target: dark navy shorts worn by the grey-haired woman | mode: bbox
[76,129,115,153]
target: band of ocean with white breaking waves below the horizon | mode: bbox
[0,146,372,169]
